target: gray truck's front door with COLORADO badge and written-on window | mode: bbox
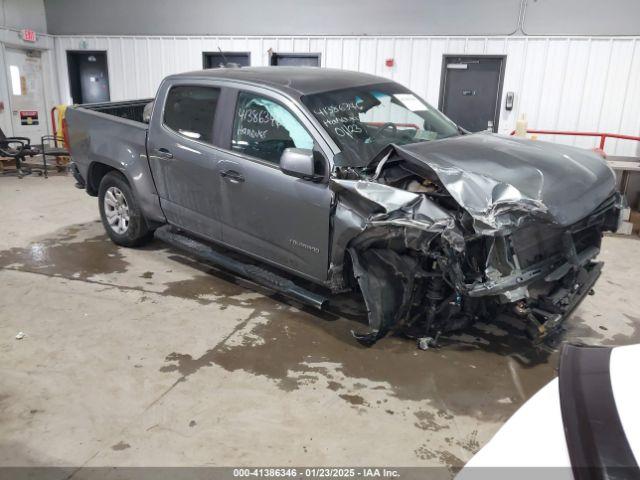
[219,91,332,281]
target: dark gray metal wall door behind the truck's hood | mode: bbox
[439,56,505,132]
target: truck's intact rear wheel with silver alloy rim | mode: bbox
[98,171,152,247]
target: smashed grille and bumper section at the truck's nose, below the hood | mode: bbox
[448,195,619,340]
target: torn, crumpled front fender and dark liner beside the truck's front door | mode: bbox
[332,180,462,345]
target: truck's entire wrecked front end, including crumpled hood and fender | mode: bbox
[332,135,620,348]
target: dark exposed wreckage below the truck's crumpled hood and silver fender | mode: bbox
[349,198,616,345]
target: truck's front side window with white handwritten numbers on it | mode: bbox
[231,92,313,164]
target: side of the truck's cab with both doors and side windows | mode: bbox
[147,71,340,282]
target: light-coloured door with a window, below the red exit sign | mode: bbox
[5,48,47,144]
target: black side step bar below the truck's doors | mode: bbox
[154,225,327,309]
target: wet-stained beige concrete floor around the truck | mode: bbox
[0,176,640,467]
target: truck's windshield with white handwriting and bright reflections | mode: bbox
[302,83,459,166]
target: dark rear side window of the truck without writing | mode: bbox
[164,85,220,143]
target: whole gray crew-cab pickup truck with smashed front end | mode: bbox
[67,67,620,348]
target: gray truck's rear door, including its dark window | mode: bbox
[147,82,225,240]
